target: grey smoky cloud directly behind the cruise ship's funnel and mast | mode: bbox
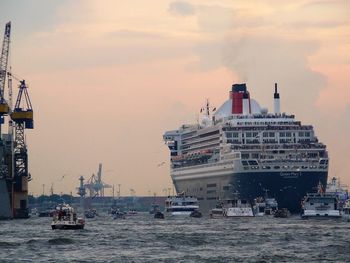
[223,36,326,115]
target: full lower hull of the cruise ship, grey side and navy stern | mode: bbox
[173,171,328,213]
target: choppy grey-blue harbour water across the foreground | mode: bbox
[0,214,350,262]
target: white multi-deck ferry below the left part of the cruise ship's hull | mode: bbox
[165,195,199,216]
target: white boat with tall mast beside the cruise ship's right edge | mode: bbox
[301,183,341,219]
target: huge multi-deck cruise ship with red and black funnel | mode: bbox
[163,84,328,212]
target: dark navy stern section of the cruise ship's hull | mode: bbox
[230,171,328,213]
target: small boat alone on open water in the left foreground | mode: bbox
[51,204,85,229]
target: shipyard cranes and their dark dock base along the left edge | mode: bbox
[0,22,34,219]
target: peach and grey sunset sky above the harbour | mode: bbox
[0,0,350,195]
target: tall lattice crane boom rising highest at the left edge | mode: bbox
[0,22,11,103]
